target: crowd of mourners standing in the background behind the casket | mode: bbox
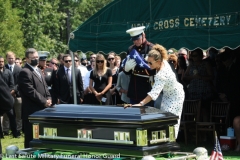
[0,48,240,137]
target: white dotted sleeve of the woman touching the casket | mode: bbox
[148,74,166,101]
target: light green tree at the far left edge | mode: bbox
[0,0,25,57]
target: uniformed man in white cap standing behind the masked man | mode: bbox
[38,51,55,105]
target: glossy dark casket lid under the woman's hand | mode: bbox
[29,104,178,122]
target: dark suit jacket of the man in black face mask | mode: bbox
[18,64,51,120]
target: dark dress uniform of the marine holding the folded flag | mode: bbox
[126,41,156,101]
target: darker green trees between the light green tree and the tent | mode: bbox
[7,0,112,57]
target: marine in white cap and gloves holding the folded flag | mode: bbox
[124,26,156,105]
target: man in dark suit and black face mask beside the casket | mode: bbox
[18,48,52,148]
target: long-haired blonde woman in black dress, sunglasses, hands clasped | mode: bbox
[89,54,112,105]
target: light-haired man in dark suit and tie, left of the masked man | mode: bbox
[3,51,22,136]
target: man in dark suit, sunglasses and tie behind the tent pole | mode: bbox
[56,54,84,104]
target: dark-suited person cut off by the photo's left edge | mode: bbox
[0,77,14,159]
